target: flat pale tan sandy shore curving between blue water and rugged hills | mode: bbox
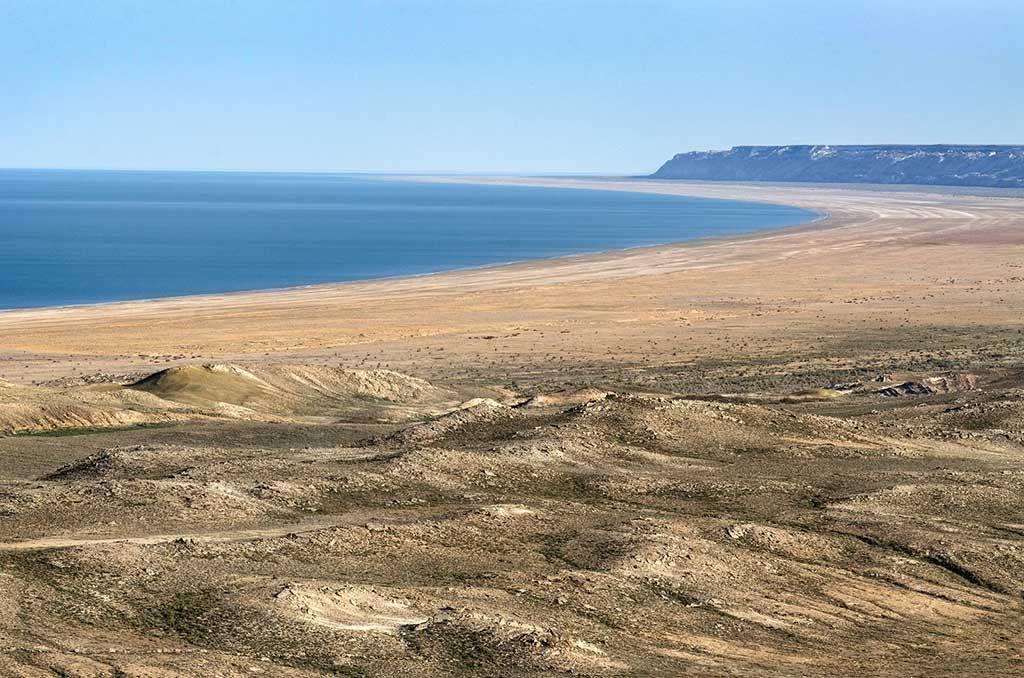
[0,177,1024,381]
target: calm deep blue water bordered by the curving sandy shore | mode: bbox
[0,170,816,308]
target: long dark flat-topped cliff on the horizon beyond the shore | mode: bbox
[651,145,1024,188]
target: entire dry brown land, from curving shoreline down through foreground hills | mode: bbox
[0,177,1024,676]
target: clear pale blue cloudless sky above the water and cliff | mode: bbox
[0,0,1024,173]
